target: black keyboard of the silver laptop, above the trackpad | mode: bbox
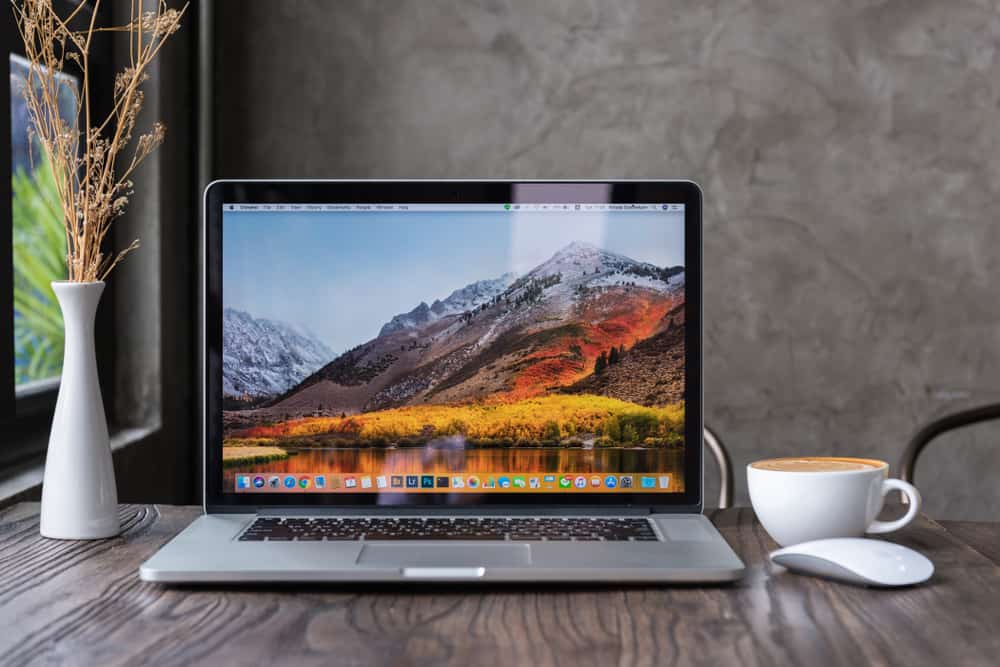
[239,517,657,542]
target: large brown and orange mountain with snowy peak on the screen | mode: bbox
[254,242,684,414]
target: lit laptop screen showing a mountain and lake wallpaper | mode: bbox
[222,202,688,494]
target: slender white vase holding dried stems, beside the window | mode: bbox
[40,281,121,540]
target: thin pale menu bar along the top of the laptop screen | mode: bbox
[222,203,684,213]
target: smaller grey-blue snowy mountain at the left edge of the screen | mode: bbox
[222,308,335,399]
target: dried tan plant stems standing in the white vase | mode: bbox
[11,0,188,282]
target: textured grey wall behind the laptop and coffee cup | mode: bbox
[215,0,1000,518]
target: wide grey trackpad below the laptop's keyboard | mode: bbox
[358,544,531,568]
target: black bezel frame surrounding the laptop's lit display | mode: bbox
[200,180,703,513]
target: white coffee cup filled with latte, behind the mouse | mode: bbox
[747,456,920,547]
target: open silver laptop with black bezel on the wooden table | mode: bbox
[140,180,744,583]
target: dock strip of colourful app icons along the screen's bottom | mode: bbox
[234,472,677,493]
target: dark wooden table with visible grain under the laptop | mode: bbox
[0,503,1000,667]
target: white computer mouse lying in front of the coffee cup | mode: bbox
[771,537,934,586]
